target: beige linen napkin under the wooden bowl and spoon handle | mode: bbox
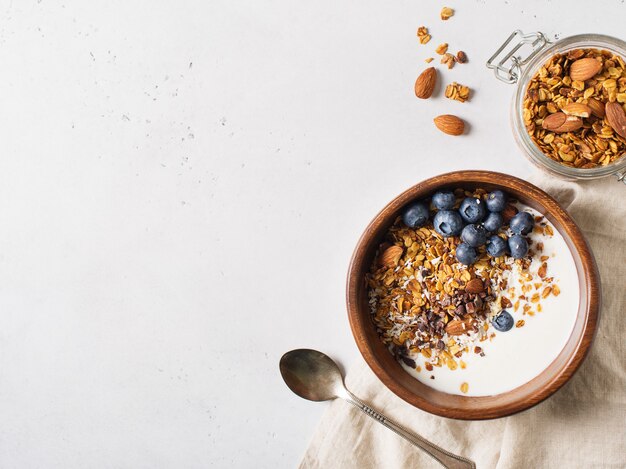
[300,176,626,469]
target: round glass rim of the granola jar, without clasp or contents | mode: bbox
[511,34,626,179]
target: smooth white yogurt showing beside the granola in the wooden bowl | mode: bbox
[402,207,580,396]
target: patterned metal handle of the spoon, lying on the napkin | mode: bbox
[346,391,476,469]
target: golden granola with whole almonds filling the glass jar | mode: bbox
[523,49,626,169]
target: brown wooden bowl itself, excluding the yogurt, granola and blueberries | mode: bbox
[346,171,600,420]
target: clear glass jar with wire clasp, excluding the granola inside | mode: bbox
[487,30,626,184]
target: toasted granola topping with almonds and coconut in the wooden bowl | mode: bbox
[367,189,560,384]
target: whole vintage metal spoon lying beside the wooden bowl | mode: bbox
[280,349,476,469]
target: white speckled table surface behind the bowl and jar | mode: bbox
[0,0,626,468]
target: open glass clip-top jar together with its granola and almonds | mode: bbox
[487,30,626,183]
